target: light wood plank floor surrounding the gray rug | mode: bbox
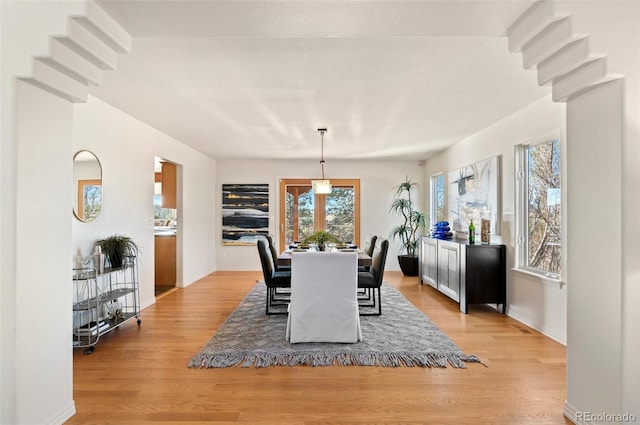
[68,272,570,425]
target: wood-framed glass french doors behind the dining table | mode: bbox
[279,179,360,249]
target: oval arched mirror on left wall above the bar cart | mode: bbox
[73,151,102,223]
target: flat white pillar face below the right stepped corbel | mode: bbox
[567,79,623,420]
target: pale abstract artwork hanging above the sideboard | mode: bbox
[448,156,500,235]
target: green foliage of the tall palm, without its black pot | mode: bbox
[390,177,427,257]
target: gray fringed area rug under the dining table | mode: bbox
[189,282,481,368]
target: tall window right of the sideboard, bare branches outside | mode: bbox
[516,134,562,279]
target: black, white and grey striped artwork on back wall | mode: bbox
[222,184,269,246]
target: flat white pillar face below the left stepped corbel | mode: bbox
[15,83,74,424]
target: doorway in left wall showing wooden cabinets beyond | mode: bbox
[153,156,178,297]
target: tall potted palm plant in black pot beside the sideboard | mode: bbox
[390,177,427,276]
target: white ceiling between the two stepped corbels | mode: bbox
[91,0,550,159]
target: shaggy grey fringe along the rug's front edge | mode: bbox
[189,353,487,369]
